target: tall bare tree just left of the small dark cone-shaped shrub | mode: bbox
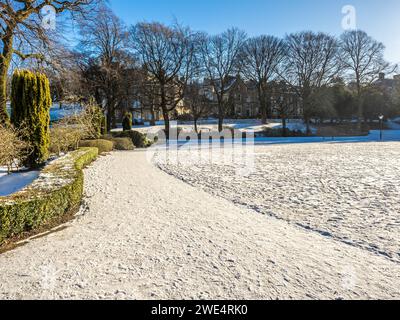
[79,6,129,128]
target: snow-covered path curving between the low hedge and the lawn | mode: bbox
[0,151,400,299]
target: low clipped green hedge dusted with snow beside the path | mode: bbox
[0,148,98,246]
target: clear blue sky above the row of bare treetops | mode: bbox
[109,0,400,63]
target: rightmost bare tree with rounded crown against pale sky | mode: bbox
[339,30,396,124]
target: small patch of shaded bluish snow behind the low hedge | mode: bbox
[0,168,40,197]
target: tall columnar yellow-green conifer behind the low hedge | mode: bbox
[11,70,52,167]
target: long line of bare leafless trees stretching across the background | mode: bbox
[0,0,399,134]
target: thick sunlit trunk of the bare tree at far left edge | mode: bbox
[0,31,13,124]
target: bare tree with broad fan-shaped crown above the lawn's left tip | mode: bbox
[130,23,196,138]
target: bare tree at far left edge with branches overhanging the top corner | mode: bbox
[0,0,97,123]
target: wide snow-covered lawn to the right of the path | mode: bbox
[155,142,400,263]
